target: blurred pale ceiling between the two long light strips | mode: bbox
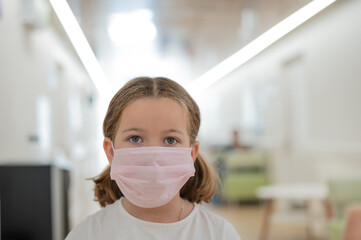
[68,0,310,85]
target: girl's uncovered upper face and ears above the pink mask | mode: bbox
[104,98,198,162]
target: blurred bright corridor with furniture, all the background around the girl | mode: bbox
[0,0,361,240]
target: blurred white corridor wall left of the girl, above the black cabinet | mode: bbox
[0,0,105,227]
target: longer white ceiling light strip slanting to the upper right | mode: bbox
[187,0,336,94]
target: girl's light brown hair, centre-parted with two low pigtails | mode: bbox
[93,77,218,207]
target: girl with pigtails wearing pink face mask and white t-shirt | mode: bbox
[66,77,240,240]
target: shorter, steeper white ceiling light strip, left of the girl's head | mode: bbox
[49,0,111,96]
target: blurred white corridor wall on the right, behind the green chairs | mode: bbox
[199,0,361,182]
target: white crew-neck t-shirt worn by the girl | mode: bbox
[65,200,240,240]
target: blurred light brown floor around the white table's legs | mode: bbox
[210,204,320,240]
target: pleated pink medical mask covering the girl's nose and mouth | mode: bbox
[110,147,195,208]
